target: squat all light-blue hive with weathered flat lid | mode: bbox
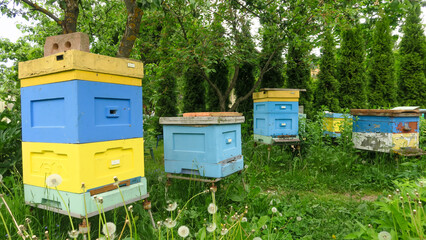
[160,113,244,178]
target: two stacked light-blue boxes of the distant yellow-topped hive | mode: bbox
[253,102,299,137]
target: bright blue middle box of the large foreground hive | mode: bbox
[21,80,143,143]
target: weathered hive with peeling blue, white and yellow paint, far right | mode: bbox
[351,107,420,152]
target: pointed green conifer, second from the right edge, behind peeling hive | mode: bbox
[368,15,397,107]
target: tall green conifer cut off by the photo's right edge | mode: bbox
[399,4,426,107]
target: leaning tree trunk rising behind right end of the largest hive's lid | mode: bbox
[117,0,143,58]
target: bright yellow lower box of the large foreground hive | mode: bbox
[22,138,144,193]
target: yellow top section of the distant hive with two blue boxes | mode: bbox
[253,89,300,102]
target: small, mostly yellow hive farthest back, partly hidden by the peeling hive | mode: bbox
[323,112,352,137]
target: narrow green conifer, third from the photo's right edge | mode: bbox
[338,26,367,108]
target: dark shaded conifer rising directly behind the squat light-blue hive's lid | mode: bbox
[183,66,206,112]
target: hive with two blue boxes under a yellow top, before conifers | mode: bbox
[253,88,301,144]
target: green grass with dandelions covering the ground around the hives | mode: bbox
[0,116,426,239]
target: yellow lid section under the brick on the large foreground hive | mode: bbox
[19,50,143,79]
